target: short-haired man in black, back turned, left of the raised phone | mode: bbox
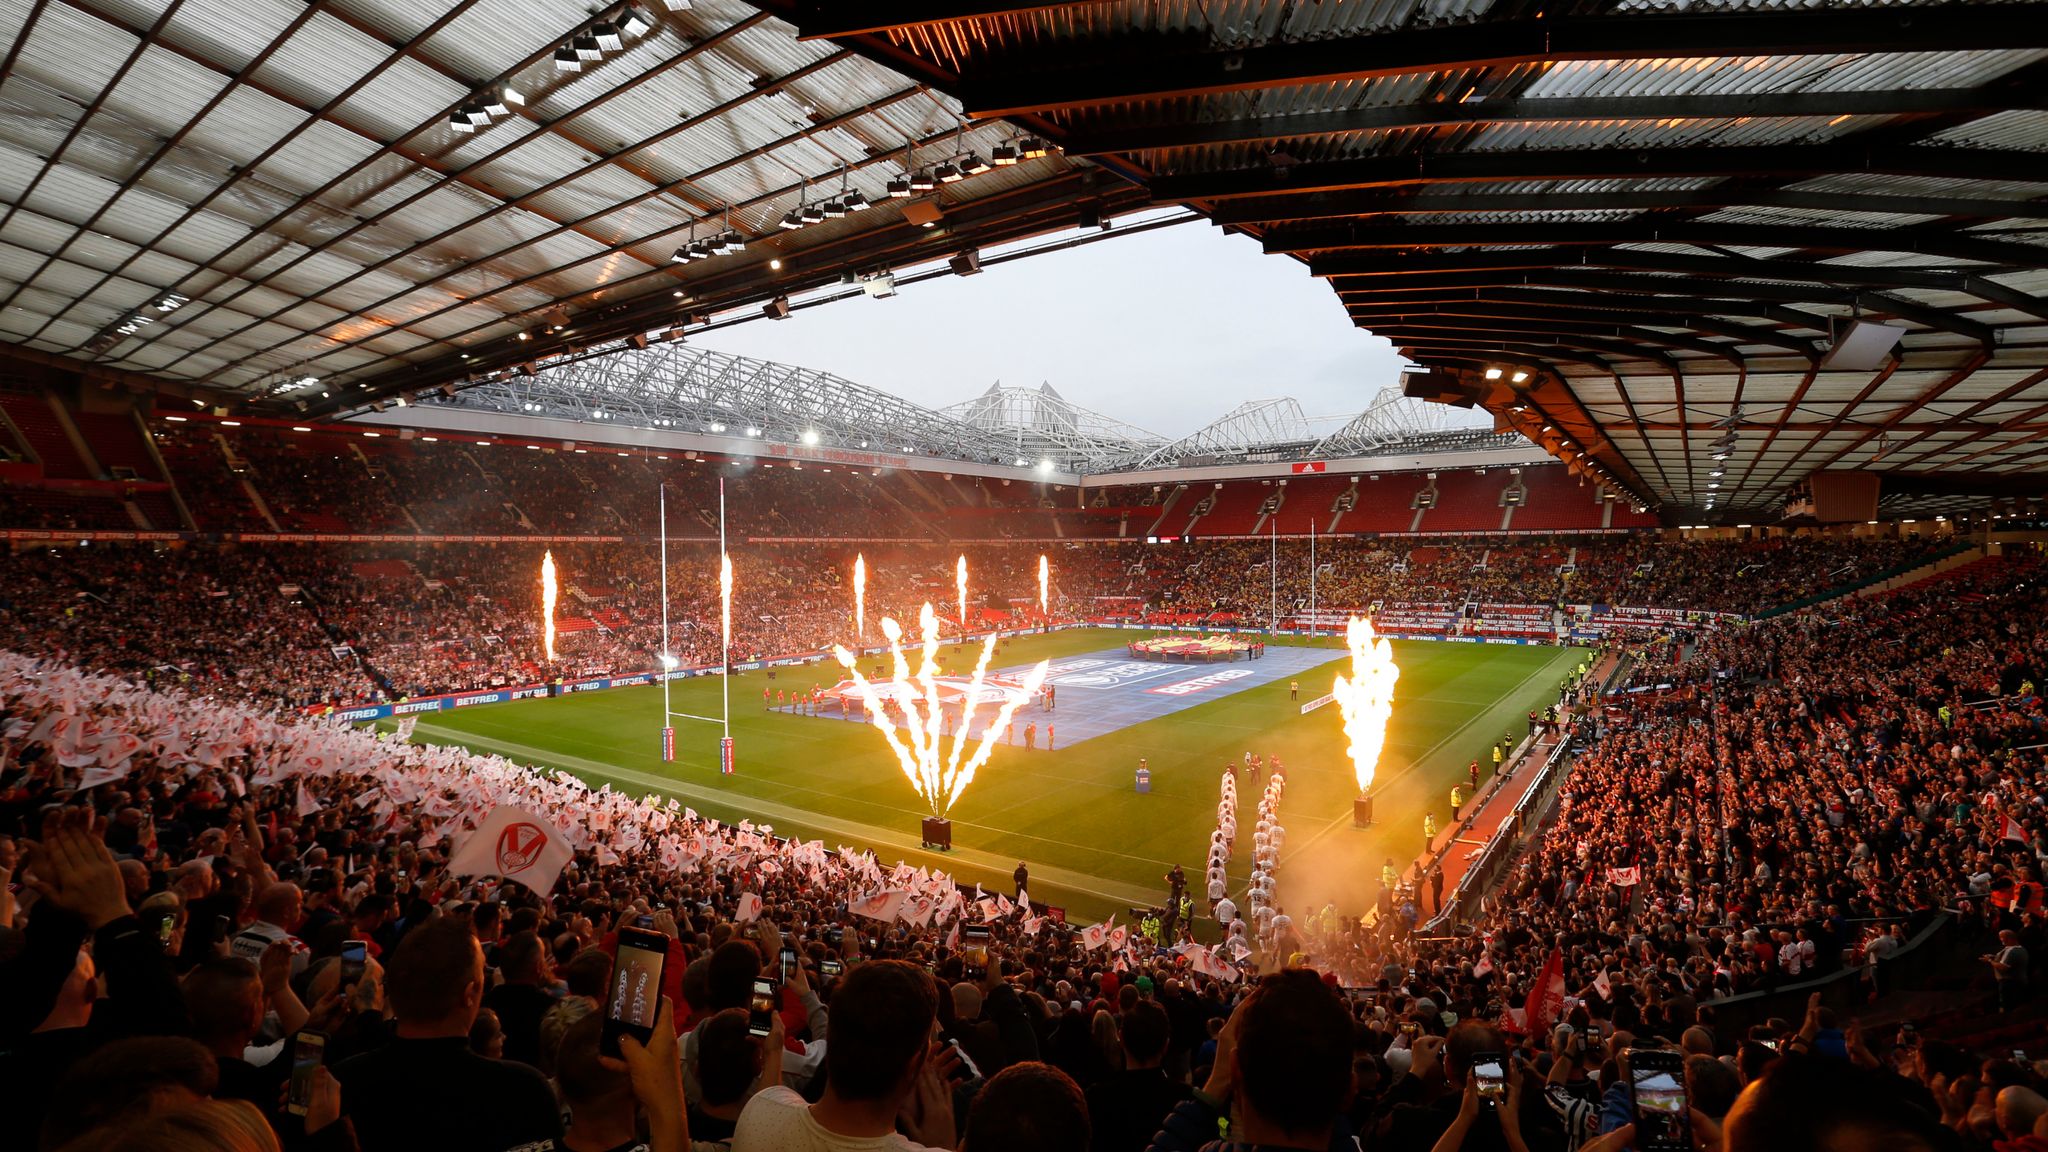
[334,916,561,1152]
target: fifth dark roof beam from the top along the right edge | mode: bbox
[1266,219,2048,269]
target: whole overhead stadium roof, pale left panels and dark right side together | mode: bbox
[12,0,2048,521]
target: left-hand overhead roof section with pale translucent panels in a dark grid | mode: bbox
[0,0,1145,414]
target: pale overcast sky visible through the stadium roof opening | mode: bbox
[690,213,1425,437]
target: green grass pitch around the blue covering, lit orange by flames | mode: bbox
[399,629,1581,916]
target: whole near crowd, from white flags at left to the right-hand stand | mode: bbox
[0,537,2048,1152]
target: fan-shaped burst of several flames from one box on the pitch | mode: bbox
[831,603,1051,818]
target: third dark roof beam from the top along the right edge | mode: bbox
[1151,143,2040,203]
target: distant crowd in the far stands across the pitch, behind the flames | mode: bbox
[0,541,1935,707]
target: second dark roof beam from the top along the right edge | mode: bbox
[1061,84,2048,156]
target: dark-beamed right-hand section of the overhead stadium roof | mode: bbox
[793,0,2048,519]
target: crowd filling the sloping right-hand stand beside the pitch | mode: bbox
[1245,556,2048,1106]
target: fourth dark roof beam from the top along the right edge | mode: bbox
[1208,184,2048,223]
